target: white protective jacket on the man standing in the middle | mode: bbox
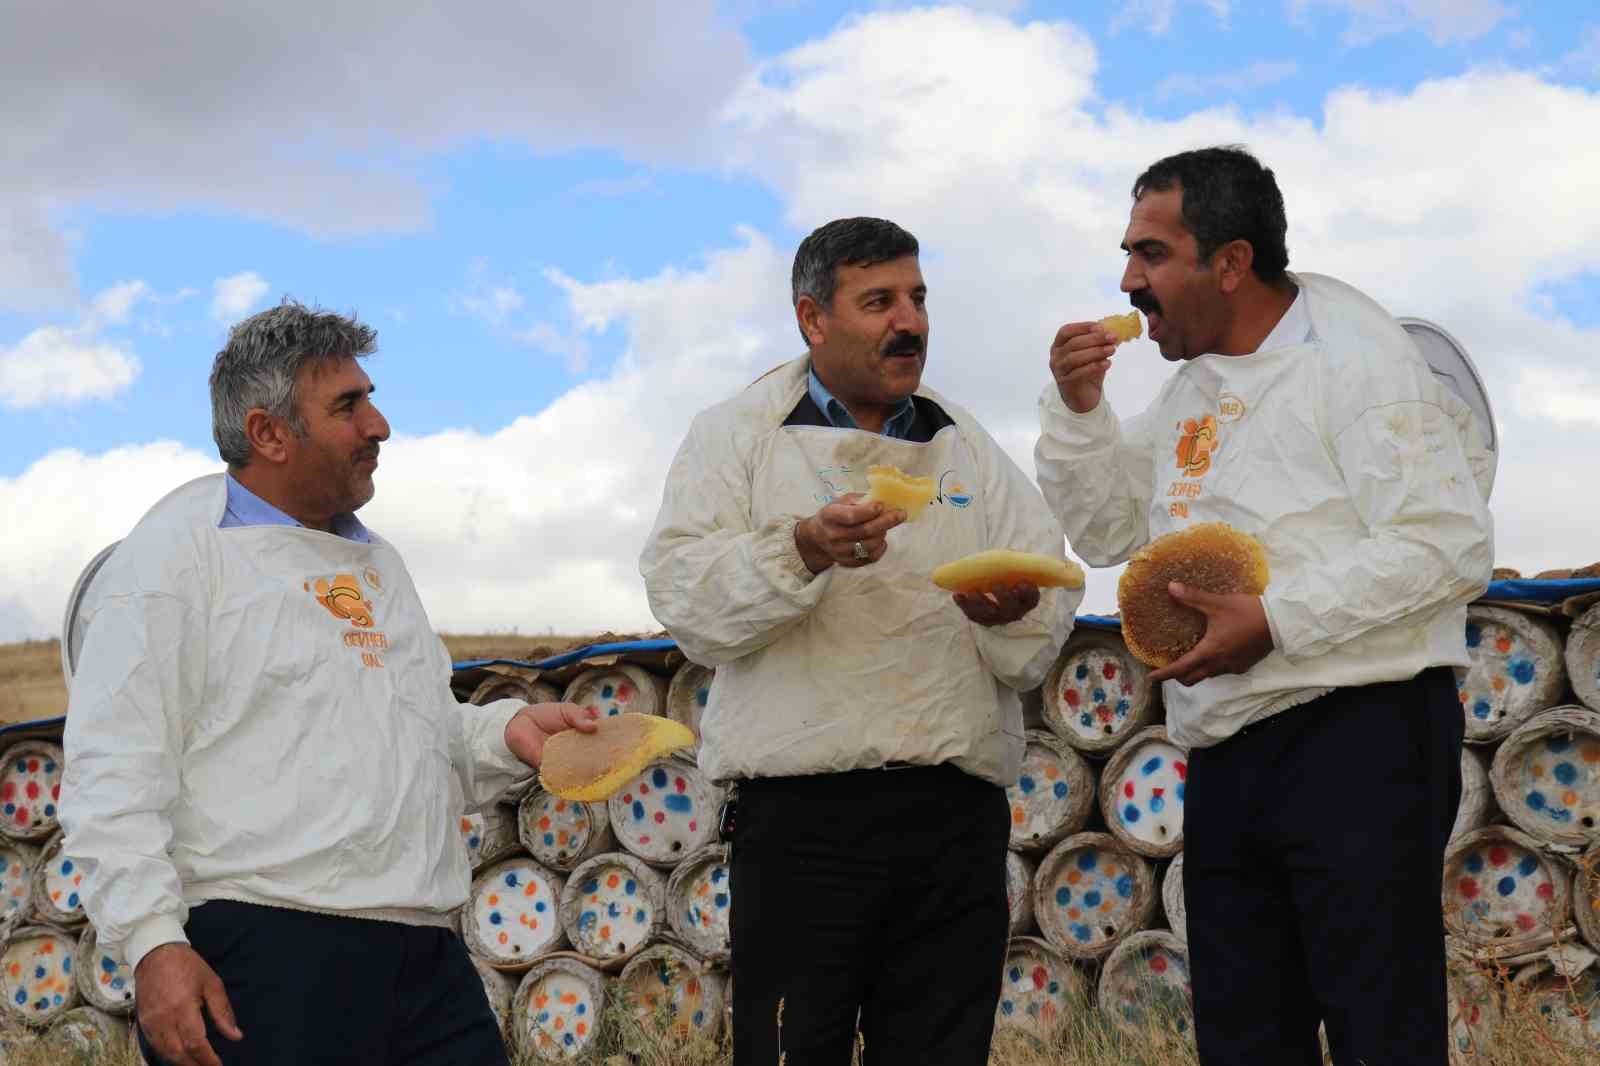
[640,359,1083,786]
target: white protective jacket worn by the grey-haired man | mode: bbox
[61,474,528,967]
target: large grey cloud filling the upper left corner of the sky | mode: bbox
[0,0,749,306]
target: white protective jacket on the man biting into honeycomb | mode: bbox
[1034,274,1494,747]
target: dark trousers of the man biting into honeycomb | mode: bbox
[1184,667,1462,1066]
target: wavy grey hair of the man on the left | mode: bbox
[211,299,378,467]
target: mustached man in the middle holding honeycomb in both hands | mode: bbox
[640,218,1083,1066]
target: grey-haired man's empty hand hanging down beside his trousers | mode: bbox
[133,941,245,1066]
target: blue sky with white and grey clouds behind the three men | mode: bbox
[0,0,1600,639]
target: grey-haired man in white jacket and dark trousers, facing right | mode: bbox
[61,301,594,1066]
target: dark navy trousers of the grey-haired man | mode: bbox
[139,900,506,1066]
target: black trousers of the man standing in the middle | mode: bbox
[730,765,1010,1066]
